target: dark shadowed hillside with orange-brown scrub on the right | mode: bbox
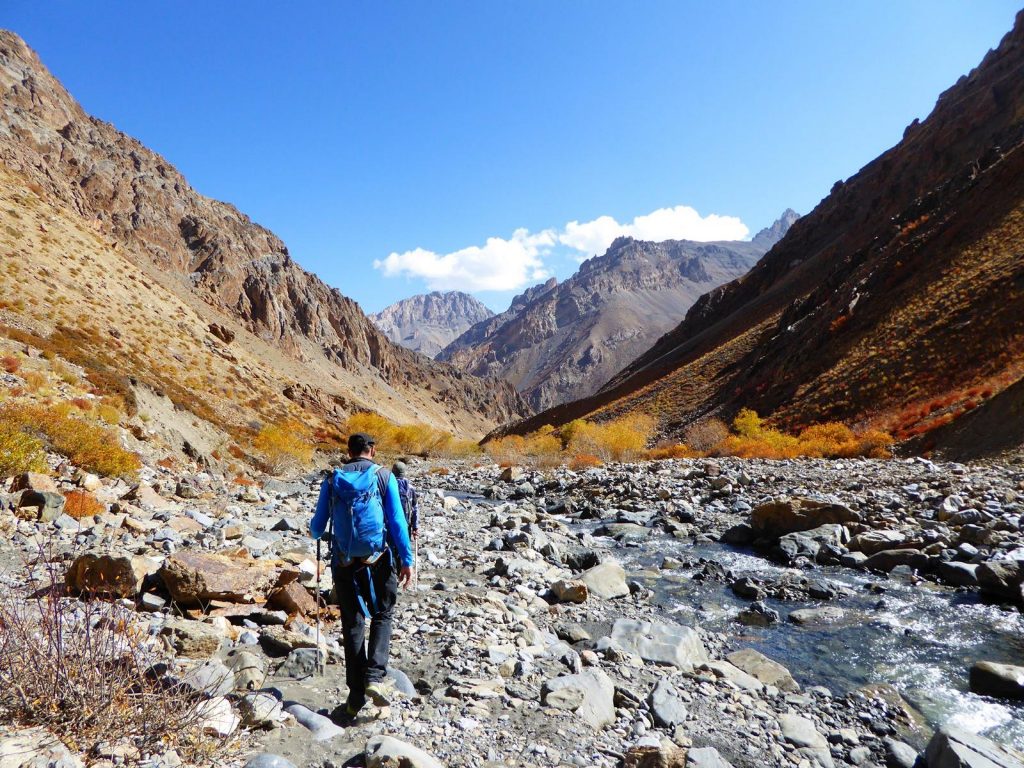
[501,12,1024,450]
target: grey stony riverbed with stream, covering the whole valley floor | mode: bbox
[0,460,1024,768]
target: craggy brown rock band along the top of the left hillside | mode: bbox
[0,32,524,432]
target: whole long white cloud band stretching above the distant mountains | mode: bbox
[374,206,750,291]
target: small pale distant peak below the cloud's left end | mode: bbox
[370,291,495,357]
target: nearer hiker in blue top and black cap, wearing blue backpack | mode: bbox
[309,432,413,724]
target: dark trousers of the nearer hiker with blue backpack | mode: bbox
[334,552,398,707]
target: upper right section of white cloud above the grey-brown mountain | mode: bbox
[558,206,750,257]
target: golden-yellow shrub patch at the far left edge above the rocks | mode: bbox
[0,403,141,477]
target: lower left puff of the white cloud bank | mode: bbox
[374,229,556,291]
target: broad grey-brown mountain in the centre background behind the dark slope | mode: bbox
[439,218,796,409]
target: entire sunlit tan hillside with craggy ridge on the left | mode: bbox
[0,32,527,435]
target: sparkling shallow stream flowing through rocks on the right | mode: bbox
[616,535,1024,749]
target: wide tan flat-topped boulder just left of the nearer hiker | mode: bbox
[159,551,276,607]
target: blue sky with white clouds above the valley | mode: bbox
[0,0,1017,311]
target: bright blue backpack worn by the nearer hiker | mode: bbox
[331,464,386,562]
